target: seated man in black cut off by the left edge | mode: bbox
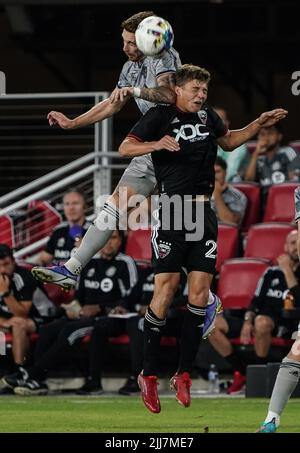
[0,244,49,380]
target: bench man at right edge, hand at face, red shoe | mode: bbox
[209,230,300,393]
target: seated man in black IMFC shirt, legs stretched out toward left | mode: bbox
[2,231,137,395]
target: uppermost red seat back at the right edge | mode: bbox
[263,182,299,222]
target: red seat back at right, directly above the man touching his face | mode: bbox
[244,222,295,264]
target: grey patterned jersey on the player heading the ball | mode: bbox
[117,48,181,115]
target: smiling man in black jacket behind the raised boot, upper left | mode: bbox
[36,188,90,265]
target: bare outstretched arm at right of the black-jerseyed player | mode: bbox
[217,109,288,151]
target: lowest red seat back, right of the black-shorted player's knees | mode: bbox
[218,258,271,309]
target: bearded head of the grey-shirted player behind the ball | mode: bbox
[122,11,155,61]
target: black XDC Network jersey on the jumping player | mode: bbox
[129,105,227,196]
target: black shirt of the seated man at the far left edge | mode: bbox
[0,266,39,319]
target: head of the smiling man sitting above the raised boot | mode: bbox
[63,188,86,225]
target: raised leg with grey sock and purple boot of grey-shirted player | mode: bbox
[32,155,156,290]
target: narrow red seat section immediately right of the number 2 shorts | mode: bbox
[216,223,239,272]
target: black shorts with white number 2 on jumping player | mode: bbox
[151,202,218,274]
